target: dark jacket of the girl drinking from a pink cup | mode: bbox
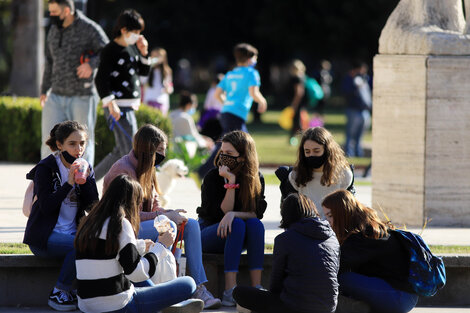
[23,154,98,249]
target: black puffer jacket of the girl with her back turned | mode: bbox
[270,218,340,313]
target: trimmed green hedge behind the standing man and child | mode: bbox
[0,97,171,164]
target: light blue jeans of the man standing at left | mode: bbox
[41,92,98,166]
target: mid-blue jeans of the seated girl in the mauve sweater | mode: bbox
[138,218,207,285]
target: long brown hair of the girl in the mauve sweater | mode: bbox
[132,124,167,211]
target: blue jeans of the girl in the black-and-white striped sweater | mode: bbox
[110,276,196,313]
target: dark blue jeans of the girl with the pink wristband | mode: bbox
[199,217,264,272]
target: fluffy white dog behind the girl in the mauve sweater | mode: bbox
[157,159,188,207]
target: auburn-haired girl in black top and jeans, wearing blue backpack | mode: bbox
[322,190,418,313]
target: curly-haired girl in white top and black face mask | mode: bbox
[276,127,353,217]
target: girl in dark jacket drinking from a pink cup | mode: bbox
[23,121,98,311]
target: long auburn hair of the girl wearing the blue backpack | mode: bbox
[322,189,394,244]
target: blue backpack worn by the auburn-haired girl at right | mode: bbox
[393,229,446,297]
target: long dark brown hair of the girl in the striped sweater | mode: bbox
[74,175,143,255]
